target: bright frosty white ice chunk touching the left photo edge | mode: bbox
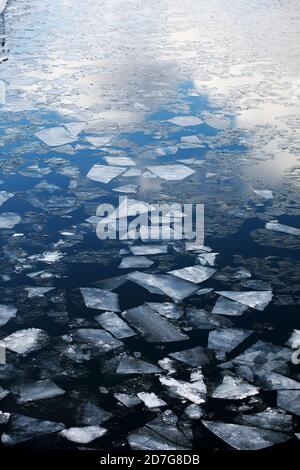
[0,328,48,354]
